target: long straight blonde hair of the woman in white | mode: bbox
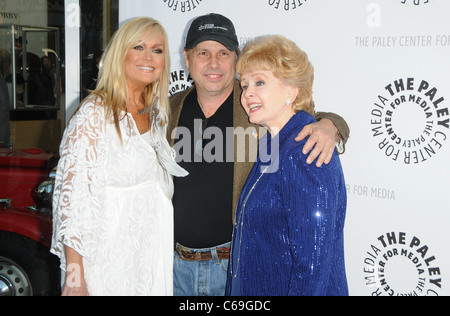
[72,17,170,138]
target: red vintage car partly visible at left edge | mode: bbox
[0,149,61,296]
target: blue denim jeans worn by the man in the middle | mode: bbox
[173,243,230,296]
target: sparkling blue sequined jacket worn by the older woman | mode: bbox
[227,112,348,296]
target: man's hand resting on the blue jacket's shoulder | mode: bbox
[295,119,339,168]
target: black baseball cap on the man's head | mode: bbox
[186,13,239,51]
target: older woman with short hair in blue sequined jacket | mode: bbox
[227,36,348,296]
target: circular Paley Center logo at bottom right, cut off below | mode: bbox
[363,231,443,296]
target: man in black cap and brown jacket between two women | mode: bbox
[168,14,349,296]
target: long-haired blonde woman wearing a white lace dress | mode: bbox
[52,18,187,296]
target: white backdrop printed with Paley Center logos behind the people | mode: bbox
[120,0,450,296]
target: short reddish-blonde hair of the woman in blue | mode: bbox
[236,35,314,114]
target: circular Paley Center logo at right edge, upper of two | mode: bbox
[370,77,450,165]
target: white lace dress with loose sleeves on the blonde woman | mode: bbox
[51,98,187,296]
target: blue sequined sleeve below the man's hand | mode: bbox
[282,150,346,296]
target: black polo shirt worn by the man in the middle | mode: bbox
[173,89,234,249]
